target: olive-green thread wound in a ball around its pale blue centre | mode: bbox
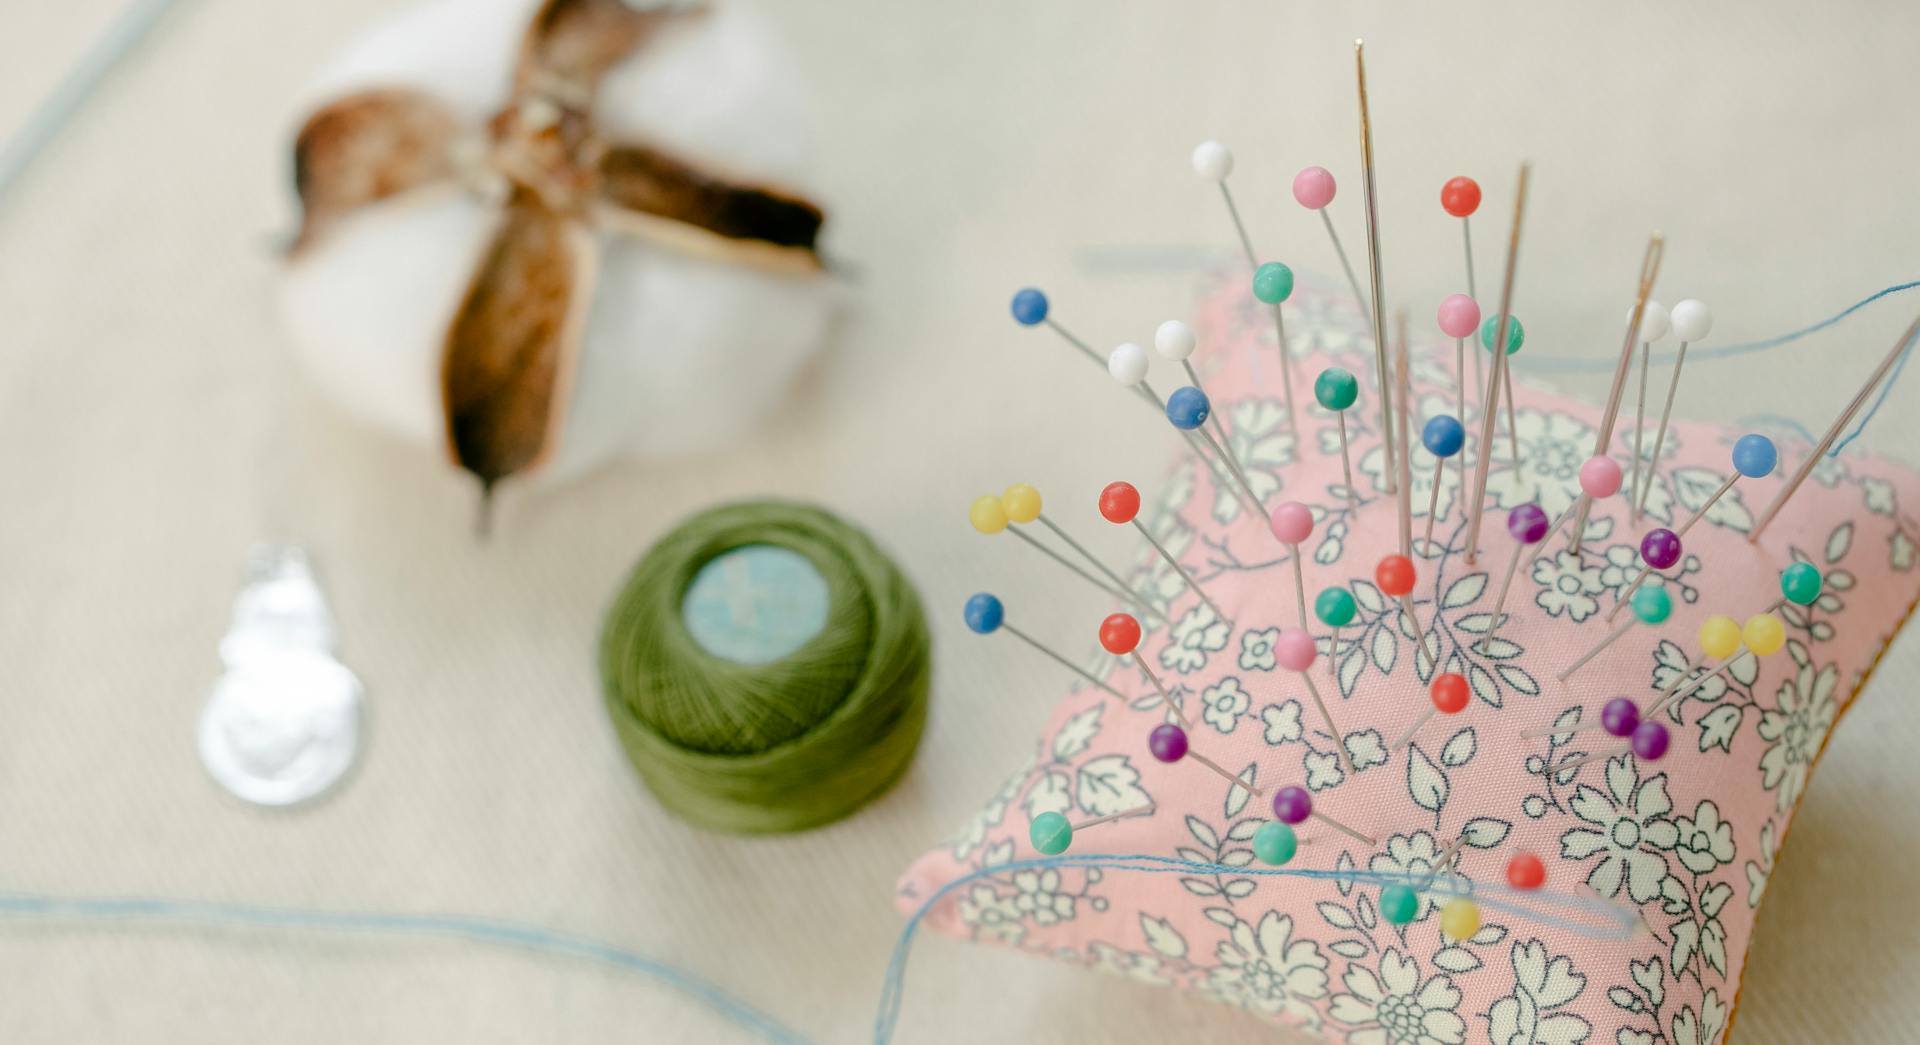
[599,501,933,834]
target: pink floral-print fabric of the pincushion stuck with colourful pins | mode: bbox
[899,272,1920,1045]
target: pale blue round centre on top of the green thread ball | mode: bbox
[680,544,828,665]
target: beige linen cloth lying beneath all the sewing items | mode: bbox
[0,0,1920,1043]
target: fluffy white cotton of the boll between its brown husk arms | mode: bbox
[280,0,839,478]
